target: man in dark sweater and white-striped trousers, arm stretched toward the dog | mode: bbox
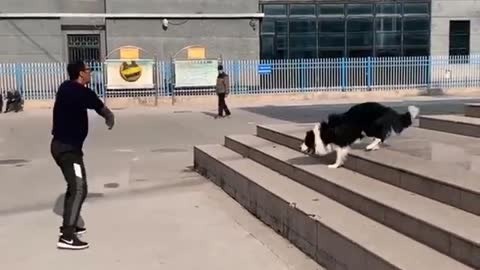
[50,62,115,249]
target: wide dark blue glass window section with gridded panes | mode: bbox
[261,0,431,58]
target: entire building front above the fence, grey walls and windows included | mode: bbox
[0,0,480,62]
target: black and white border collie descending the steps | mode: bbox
[300,102,420,168]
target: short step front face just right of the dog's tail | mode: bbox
[419,117,480,138]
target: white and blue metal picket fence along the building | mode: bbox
[0,55,480,100]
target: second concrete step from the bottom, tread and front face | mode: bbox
[225,135,480,268]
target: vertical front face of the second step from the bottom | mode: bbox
[225,137,480,268]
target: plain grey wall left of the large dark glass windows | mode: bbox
[0,0,260,62]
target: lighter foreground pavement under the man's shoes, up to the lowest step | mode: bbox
[0,177,321,270]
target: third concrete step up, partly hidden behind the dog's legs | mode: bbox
[257,124,480,215]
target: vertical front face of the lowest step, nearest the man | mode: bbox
[194,148,398,270]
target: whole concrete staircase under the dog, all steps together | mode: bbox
[194,106,480,270]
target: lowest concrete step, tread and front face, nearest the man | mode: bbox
[194,145,472,270]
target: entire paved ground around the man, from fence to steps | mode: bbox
[0,96,478,269]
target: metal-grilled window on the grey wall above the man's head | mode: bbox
[67,34,100,62]
